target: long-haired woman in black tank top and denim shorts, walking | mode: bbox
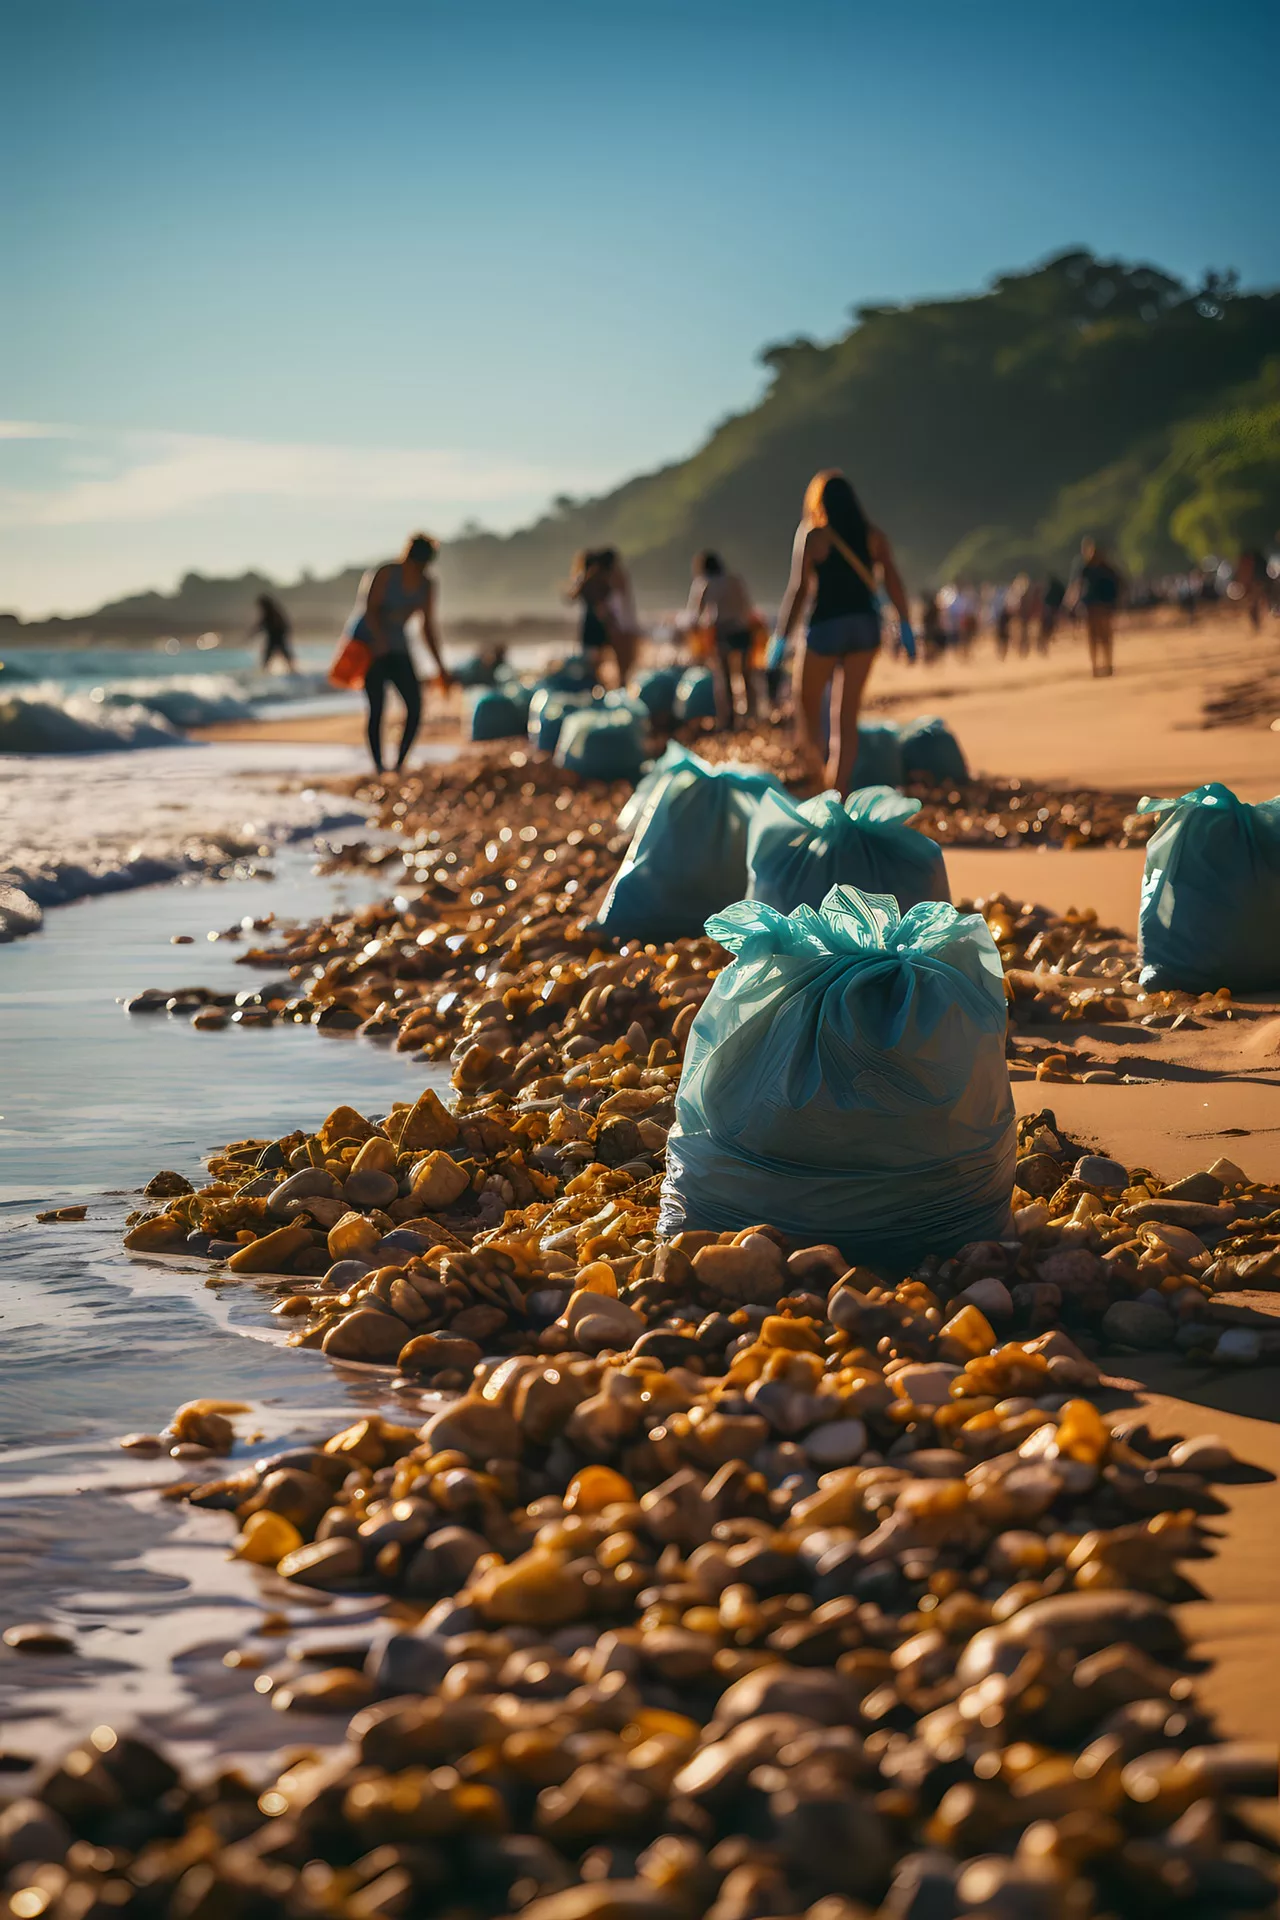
[777,470,912,797]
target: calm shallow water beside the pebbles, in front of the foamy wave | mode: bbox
[0,849,452,1766]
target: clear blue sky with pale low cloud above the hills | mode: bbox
[0,0,1280,612]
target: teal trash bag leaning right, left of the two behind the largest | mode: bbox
[598,728,777,941]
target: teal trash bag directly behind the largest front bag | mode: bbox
[747,787,952,914]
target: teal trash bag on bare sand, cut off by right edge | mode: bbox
[1138,781,1280,993]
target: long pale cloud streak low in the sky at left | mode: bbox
[0,420,594,526]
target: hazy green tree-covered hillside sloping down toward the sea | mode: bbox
[12,252,1280,634]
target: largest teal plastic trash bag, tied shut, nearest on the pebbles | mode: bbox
[658,887,1015,1279]
